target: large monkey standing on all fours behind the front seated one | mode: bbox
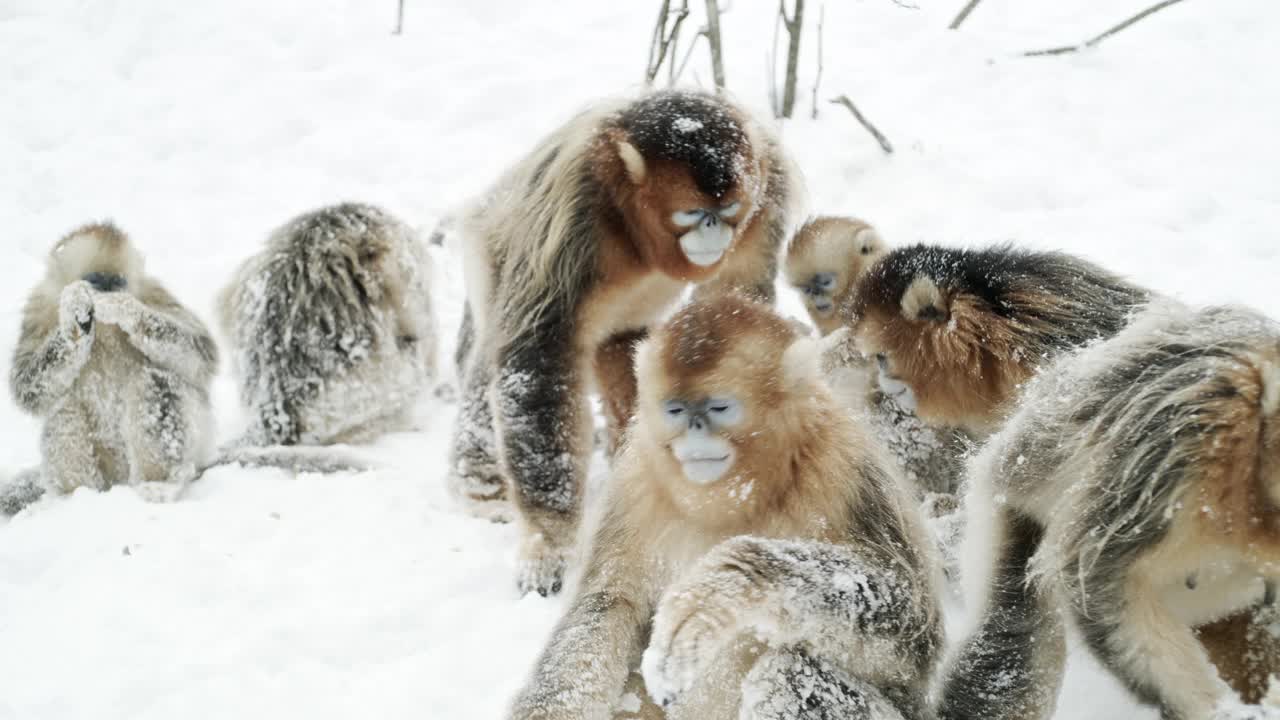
[449,91,794,593]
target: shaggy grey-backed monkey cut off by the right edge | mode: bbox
[941,301,1280,720]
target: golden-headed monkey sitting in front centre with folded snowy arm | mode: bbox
[511,296,942,720]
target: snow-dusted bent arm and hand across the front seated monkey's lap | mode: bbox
[644,537,941,703]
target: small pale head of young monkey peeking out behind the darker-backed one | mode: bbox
[785,217,887,334]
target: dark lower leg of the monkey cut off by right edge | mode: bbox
[938,507,1066,720]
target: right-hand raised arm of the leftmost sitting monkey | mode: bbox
[95,292,218,386]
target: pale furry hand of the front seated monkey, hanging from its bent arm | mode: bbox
[640,538,763,707]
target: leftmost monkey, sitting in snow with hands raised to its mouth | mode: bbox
[5,223,218,502]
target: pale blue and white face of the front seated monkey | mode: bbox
[662,395,746,486]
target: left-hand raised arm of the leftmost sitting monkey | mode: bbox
[9,282,95,416]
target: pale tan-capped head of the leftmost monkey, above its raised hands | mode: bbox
[46,223,143,292]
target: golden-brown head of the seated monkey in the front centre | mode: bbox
[634,295,822,517]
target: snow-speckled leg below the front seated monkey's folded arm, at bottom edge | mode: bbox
[740,647,904,720]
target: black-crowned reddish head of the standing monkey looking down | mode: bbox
[595,91,767,282]
